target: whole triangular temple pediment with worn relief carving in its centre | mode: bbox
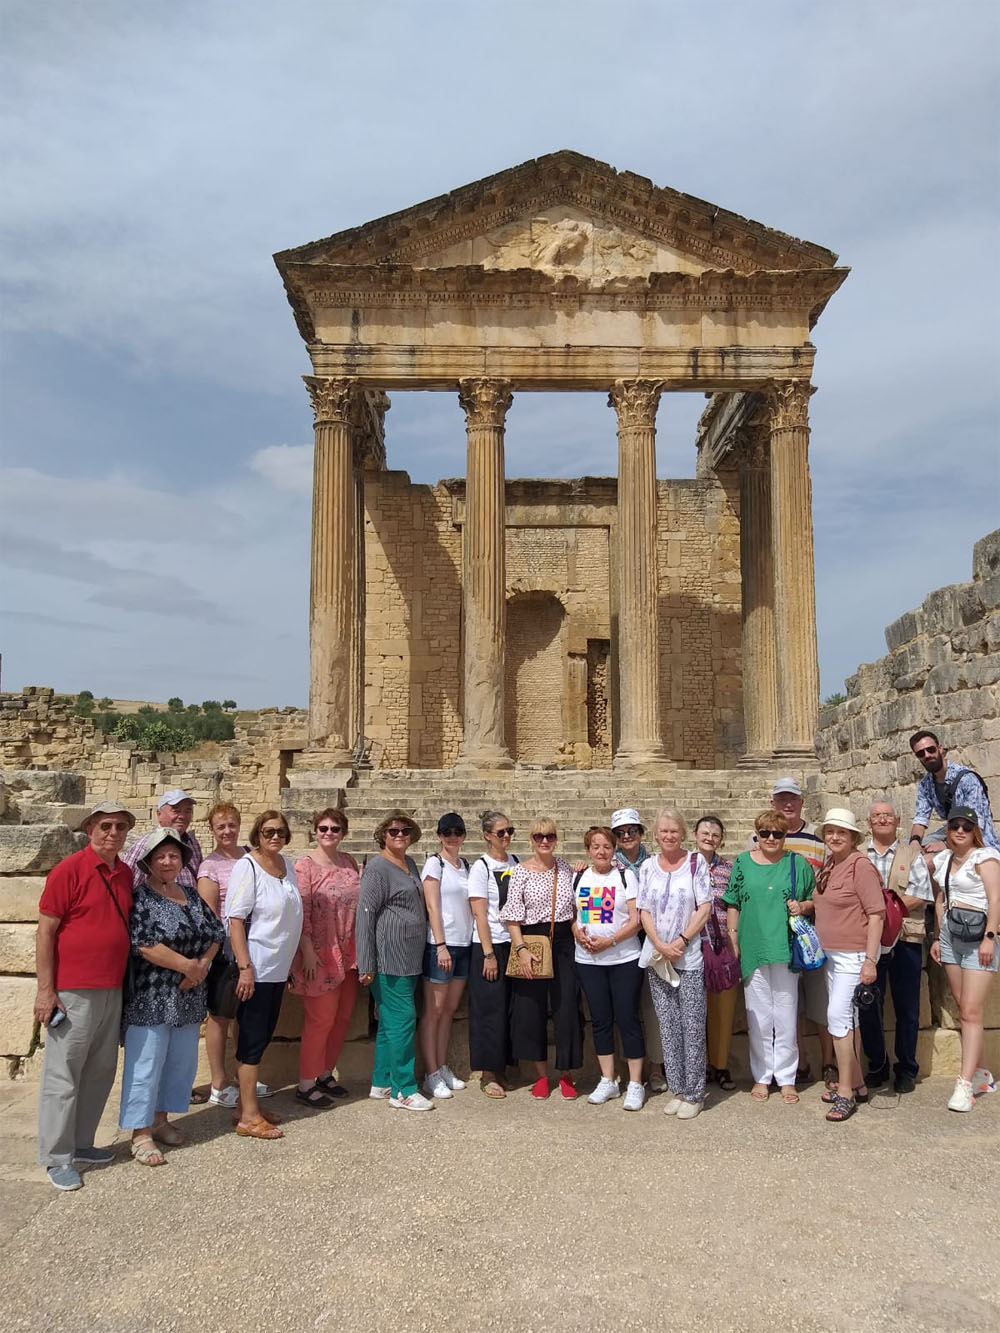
[275,149,836,283]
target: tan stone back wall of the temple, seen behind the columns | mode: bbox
[365,472,743,768]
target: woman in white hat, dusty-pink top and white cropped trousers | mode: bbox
[812,808,885,1124]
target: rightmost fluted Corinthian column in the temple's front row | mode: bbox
[767,380,820,756]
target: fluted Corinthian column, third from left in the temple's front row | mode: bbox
[608,380,664,764]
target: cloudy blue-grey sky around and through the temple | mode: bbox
[0,0,1000,706]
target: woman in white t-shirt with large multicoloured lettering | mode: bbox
[573,824,645,1110]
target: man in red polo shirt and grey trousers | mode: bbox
[35,801,135,1189]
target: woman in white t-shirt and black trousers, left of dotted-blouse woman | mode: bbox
[469,810,517,1098]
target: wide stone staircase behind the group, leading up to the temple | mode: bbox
[281,765,805,860]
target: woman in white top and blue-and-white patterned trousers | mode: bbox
[639,806,712,1120]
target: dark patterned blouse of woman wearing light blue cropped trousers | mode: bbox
[121,884,224,1028]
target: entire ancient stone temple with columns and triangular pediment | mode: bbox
[275,152,847,773]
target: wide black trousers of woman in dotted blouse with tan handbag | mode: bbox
[511,921,583,1069]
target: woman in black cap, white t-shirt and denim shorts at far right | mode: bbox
[931,808,1000,1110]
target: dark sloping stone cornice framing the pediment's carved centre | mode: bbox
[275,149,837,275]
